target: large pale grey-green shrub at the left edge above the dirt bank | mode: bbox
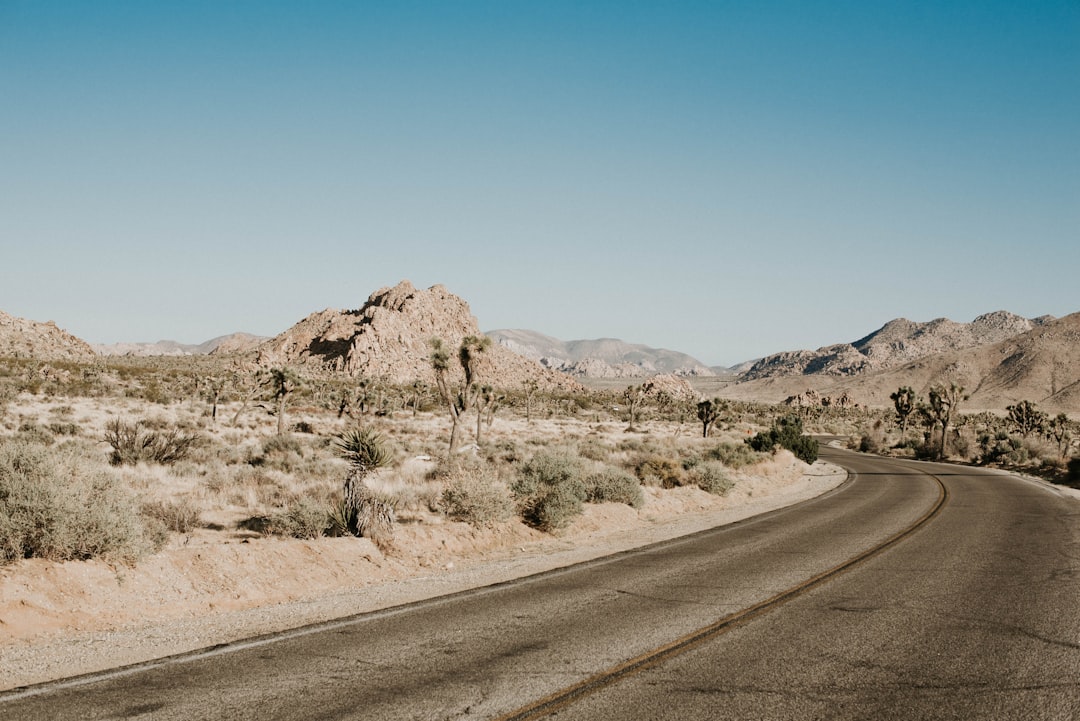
[0,443,166,562]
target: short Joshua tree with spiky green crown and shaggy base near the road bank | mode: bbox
[332,428,395,542]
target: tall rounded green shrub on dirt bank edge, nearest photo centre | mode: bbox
[510,449,585,531]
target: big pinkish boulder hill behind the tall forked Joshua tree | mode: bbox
[256,281,580,391]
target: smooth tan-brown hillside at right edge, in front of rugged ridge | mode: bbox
[725,313,1080,414]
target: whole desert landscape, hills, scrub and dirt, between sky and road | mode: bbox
[0,282,1080,688]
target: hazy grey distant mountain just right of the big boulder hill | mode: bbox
[487,329,715,378]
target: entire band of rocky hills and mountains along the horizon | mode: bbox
[0,293,1080,412]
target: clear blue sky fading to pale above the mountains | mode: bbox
[0,0,1080,365]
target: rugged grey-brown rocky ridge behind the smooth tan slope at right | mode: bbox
[742,311,1053,380]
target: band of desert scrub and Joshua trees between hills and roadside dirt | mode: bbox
[10,351,1080,563]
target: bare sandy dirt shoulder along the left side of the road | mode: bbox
[0,451,847,690]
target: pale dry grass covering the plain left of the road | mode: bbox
[0,368,820,561]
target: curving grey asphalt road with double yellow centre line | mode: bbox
[0,450,1080,721]
